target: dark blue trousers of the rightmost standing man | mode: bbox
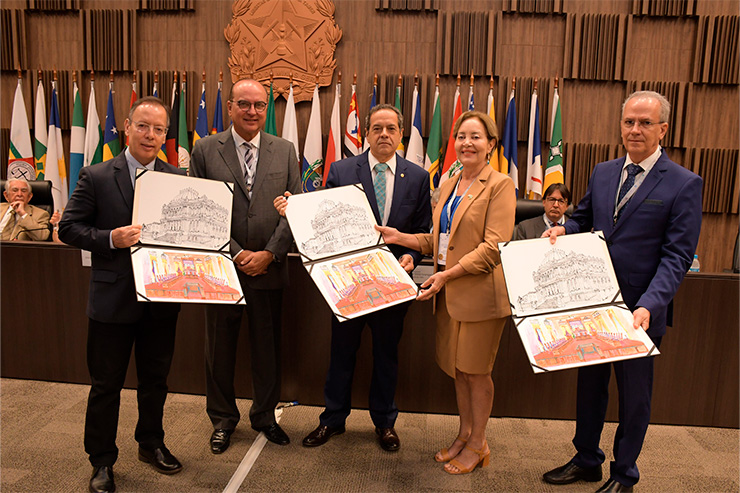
[573,337,661,486]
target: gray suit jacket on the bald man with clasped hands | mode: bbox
[190,128,301,289]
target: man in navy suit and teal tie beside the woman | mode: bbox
[275,104,432,452]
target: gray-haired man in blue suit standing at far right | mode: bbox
[543,91,702,491]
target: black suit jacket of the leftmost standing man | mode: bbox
[59,152,185,323]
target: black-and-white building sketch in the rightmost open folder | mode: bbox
[517,248,615,312]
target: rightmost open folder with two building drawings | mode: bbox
[499,231,660,373]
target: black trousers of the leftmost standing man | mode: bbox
[85,307,177,467]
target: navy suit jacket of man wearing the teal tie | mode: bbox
[326,150,432,265]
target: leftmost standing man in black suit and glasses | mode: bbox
[59,97,185,492]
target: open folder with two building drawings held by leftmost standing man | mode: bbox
[131,171,245,304]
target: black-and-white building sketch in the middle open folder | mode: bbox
[301,200,378,257]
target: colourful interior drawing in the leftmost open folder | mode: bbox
[142,250,242,303]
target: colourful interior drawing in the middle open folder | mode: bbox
[318,251,416,317]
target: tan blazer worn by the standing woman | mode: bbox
[416,166,516,322]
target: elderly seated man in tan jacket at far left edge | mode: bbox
[0,178,50,241]
